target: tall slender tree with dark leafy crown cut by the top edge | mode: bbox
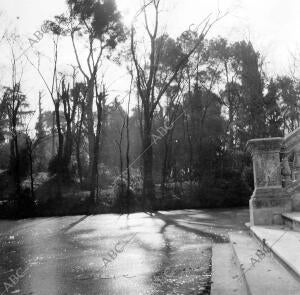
[60,0,125,199]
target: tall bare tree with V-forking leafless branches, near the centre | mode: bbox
[131,0,224,209]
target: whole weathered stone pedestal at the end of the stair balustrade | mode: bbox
[247,137,291,225]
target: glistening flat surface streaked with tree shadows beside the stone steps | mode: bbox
[0,209,249,295]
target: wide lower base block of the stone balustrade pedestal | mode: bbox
[249,190,292,226]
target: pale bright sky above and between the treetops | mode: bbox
[0,0,300,114]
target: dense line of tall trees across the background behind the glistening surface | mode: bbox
[0,0,300,215]
